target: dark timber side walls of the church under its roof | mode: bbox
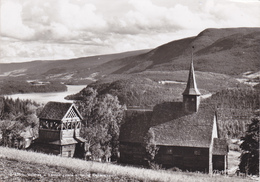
[119,142,213,172]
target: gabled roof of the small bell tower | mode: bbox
[39,102,81,120]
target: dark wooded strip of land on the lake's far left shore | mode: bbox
[0,80,67,95]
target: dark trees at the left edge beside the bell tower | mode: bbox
[0,97,41,148]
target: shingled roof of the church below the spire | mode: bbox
[120,103,215,147]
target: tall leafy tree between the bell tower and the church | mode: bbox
[76,88,125,161]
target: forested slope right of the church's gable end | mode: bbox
[206,88,260,138]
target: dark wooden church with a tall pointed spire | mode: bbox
[119,57,228,173]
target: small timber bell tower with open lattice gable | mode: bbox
[30,102,85,158]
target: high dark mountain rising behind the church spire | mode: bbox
[97,28,260,75]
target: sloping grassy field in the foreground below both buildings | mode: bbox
[0,147,251,182]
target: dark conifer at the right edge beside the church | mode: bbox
[239,117,260,175]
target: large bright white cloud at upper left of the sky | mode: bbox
[20,0,106,41]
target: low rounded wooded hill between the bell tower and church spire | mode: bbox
[66,77,184,107]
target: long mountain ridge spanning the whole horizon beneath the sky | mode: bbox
[0,28,260,84]
